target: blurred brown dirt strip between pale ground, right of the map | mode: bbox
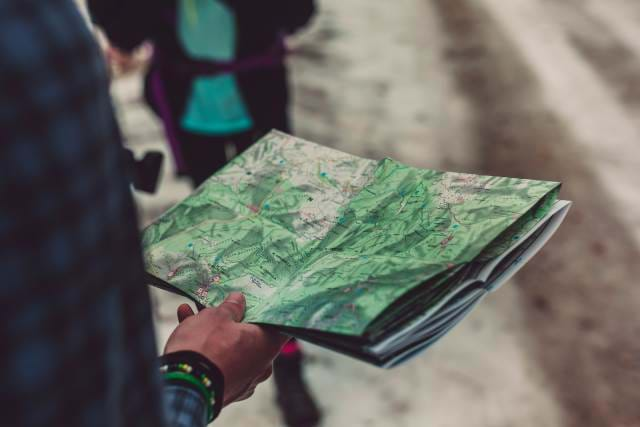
[434,0,640,427]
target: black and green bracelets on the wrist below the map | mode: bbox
[160,351,224,422]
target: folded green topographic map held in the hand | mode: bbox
[143,131,570,367]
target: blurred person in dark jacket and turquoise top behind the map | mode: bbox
[88,0,320,427]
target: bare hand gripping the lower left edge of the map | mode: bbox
[164,293,289,406]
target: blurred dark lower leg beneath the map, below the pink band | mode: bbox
[273,353,320,427]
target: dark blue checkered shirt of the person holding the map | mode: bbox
[0,0,206,427]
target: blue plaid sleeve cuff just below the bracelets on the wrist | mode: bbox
[163,384,207,427]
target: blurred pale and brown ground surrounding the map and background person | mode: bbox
[85,0,640,427]
